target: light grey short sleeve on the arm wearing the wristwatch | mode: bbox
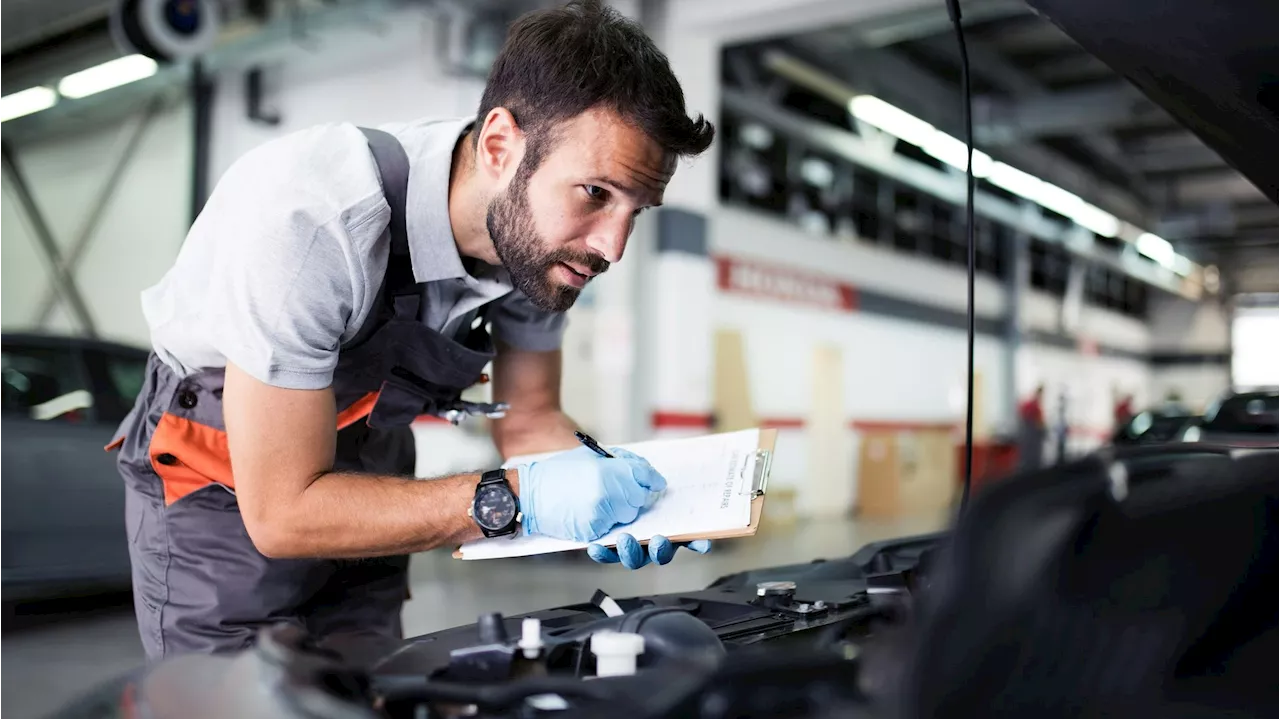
[188,127,376,389]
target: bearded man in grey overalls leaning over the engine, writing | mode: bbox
[113,0,714,659]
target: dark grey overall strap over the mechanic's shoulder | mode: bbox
[346,128,422,347]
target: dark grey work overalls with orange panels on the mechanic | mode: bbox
[108,129,494,660]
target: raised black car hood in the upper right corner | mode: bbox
[1027,0,1280,203]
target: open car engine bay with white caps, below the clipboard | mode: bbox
[47,446,1280,719]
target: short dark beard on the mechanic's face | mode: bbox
[485,171,609,312]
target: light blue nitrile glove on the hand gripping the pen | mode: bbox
[520,446,667,541]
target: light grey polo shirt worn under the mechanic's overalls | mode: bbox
[142,118,566,389]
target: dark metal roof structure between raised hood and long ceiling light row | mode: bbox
[727,0,1280,292]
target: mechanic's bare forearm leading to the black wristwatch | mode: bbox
[255,471,520,559]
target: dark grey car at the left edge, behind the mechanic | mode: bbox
[0,334,147,603]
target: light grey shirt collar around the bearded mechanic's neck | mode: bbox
[402,116,511,292]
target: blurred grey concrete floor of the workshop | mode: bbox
[0,509,945,719]
